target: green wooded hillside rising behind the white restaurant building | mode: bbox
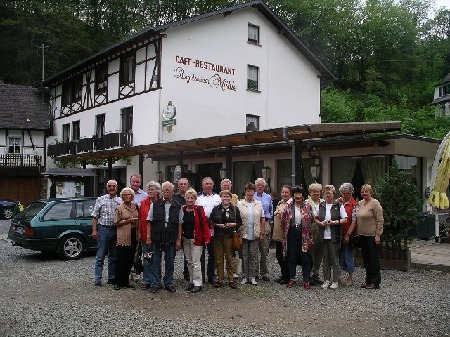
[0,0,450,138]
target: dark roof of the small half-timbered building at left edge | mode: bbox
[0,84,50,130]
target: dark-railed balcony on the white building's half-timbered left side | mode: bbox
[47,132,133,158]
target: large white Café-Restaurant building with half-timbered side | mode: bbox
[45,1,438,201]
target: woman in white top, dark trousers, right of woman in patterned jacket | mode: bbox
[306,183,323,285]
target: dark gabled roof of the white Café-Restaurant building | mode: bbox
[44,0,336,86]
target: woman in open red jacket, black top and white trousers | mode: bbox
[181,188,211,293]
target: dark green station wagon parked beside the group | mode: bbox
[8,198,97,259]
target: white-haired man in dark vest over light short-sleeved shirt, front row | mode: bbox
[147,181,183,294]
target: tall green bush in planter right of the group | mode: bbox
[374,160,422,247]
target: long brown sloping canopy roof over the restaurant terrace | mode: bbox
[54,121,401,160]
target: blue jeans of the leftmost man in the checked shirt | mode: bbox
[94,225,117,283]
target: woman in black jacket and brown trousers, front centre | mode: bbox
[209,190,242,289]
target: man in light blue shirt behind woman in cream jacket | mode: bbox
[254,178,273,281]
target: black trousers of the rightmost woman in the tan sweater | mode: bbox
[359,235,381,285]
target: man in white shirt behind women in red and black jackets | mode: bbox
[195,177,222,284]
